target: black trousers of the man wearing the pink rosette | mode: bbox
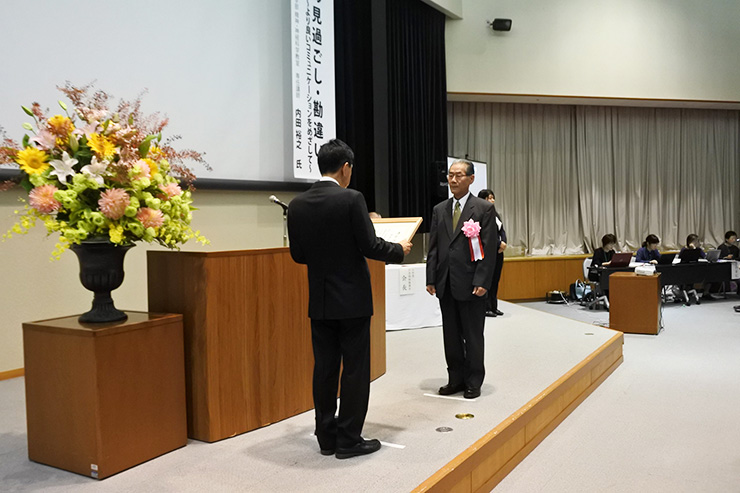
[439,285,486,389]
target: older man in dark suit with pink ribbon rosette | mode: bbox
[427,159,497,399]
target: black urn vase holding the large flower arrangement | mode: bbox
[71,239,134,323]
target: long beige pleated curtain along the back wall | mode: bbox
[448,103,740,255]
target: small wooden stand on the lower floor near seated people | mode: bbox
[609,272,660,334]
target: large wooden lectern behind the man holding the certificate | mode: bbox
[147,248,385,442]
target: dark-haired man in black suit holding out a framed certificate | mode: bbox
[288,140,411,459]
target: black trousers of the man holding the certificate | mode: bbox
[311,317,370,450]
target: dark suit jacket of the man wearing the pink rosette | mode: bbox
[427,195,498,301]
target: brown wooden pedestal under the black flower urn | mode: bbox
[23,312,187,479]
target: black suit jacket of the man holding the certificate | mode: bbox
[288,181,404,320]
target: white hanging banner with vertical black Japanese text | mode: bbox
[291,0,336,179]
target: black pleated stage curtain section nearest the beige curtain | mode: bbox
[386,0,447,231]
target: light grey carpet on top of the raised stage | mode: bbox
[0,303,612,492]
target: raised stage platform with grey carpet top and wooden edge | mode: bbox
[2,302,623,493]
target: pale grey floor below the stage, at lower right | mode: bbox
[495,296,740,493]
